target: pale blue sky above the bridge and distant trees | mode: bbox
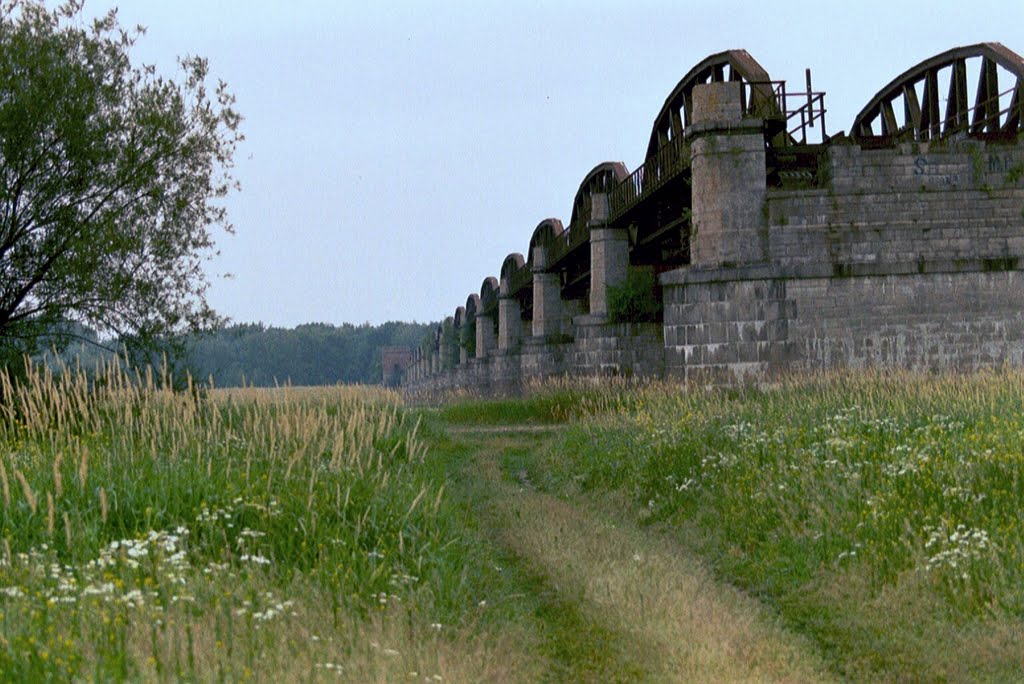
[86,0,1024,326]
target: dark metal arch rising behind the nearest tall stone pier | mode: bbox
[647,50,778,158]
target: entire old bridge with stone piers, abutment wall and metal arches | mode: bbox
[402,43,1024,395]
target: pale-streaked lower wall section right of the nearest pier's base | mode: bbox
[786,270,1024,371]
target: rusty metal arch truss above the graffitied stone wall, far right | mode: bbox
[851,43,1024,141]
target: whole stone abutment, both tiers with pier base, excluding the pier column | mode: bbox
[662,135,1024,383]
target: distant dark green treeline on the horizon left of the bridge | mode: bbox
[37,322,437,387]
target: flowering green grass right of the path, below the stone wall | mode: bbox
[547,372,1024,680]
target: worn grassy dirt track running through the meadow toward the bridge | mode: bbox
[447,426,830,682]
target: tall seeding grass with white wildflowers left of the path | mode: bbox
[0,364,491,681]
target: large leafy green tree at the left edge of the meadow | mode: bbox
[0,0,242,370]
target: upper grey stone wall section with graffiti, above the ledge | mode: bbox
[766,140,1024,266]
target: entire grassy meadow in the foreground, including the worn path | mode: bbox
[0,367,1024,682]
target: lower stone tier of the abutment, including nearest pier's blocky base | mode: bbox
[665,260,1024,384]
